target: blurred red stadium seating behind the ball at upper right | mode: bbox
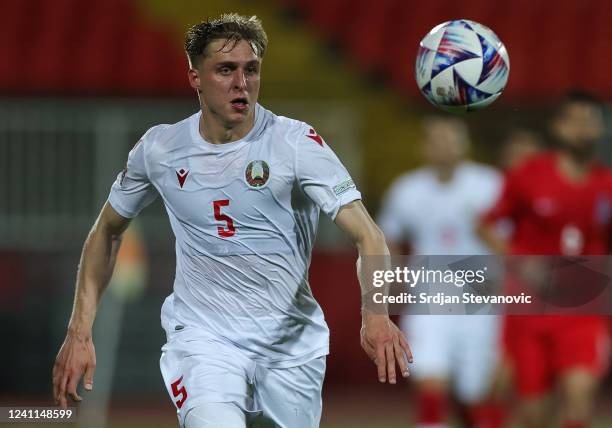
[295,0,612,100]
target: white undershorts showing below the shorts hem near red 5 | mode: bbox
[185,403,246,428]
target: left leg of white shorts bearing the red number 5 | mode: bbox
[160,336,255,424]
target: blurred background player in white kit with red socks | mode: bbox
[379,116,501,427]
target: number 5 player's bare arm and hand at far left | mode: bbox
[53,202,130,408]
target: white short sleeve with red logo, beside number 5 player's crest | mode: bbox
[295,126,361,220]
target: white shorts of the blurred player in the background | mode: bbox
[400,315,501,404]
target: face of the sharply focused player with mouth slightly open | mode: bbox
[189,39,261,128]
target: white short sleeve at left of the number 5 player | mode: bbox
[108,130,157,218]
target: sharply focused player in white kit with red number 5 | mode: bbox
[53,14,412,428]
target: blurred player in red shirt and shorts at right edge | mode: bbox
[479,93,612,428]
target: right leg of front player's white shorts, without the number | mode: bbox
[253,357,325,428]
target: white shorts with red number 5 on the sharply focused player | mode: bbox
[160,329,325,428]
